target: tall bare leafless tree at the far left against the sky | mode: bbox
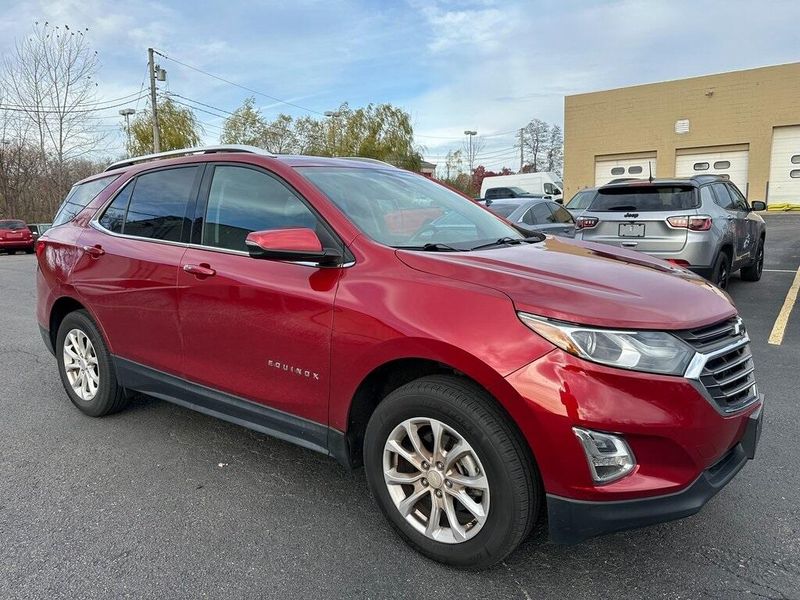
[0,21,102,203]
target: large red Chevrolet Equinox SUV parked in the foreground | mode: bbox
[37,146,763,568]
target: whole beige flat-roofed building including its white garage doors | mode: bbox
[564,63,800,210]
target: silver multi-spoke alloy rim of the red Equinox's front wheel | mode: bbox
[383,417,489,544]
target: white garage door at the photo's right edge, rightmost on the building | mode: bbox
[767,125,800,210]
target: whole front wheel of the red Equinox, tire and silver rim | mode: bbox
[364,375,542,569]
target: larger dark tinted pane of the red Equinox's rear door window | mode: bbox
[123,166,200,242]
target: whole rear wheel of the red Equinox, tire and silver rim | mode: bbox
[56,310,127,417]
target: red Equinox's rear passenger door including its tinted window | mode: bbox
[72,165,203,374]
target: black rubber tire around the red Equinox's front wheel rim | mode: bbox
[364,375,543,569]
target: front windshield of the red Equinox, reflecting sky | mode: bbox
[297,167,522,250]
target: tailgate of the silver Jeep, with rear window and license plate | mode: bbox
[581,183,698,255]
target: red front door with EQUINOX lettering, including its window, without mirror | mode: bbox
[178,164,341,423]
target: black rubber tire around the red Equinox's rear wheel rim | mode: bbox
[56,310,128,417]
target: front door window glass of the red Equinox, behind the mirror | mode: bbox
[202,165,320,252]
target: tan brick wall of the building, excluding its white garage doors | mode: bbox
[564,63,800,200]
